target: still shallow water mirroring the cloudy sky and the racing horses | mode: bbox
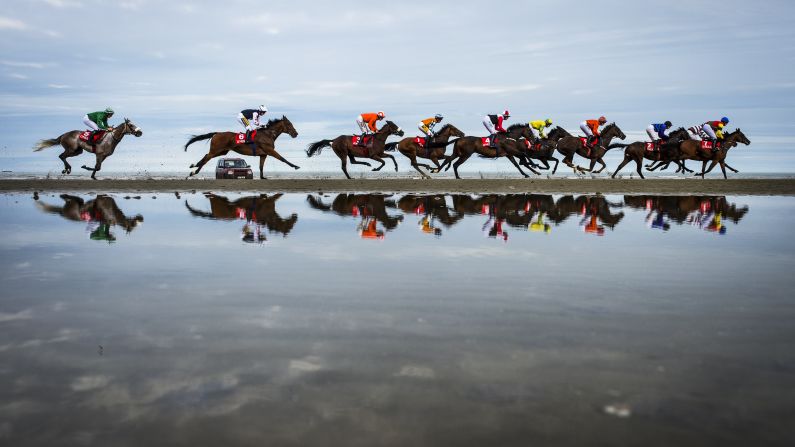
[0,193,795,446]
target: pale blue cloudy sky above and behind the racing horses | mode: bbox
[0,0,795,172]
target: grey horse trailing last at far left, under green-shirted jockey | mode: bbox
[33,118,143,180]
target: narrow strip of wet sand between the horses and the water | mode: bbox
[0,178,795,196]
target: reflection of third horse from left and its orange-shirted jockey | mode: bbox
[306,194,403,239]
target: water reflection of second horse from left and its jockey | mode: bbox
[185,193,298,243]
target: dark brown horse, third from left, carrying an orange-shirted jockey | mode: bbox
[306,121,404,179]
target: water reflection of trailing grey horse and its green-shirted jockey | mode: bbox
[34,194,144,243]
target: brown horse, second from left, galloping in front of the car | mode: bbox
[185,115,300,179]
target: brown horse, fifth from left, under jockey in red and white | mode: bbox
[439,124,541,179]
